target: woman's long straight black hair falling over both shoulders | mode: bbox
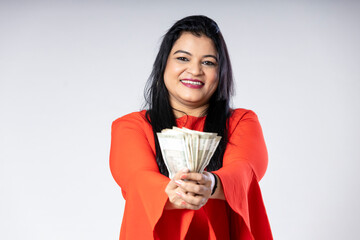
[144,15,233,176]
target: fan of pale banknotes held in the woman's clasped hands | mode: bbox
[157,127,221,178]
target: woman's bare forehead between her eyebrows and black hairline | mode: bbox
[171,32,217,55]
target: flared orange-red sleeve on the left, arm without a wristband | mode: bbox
[110,113,193,240]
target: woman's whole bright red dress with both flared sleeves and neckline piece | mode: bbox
[110,109,272,240]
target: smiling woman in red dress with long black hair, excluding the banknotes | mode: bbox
[110,16,272,239]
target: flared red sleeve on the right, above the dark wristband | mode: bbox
[215,109,272,239]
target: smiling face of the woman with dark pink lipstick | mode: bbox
[164,32,219,114]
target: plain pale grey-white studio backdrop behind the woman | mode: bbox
[0,0,360,240]
